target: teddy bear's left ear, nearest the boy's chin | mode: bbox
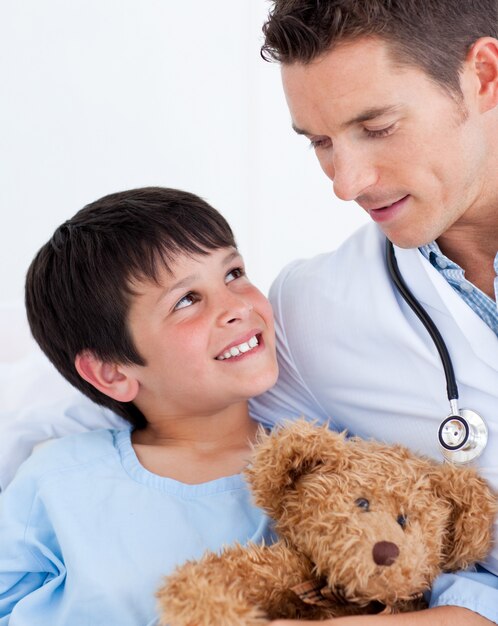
[245,419,347,516]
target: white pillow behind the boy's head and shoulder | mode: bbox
[0,303,128,491]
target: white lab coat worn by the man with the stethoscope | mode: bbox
[252,223,498,574]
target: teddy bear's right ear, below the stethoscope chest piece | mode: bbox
[431,463,498,571]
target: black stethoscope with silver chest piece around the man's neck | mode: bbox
[386,239,488,465]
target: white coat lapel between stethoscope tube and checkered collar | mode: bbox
[395,246,498,369]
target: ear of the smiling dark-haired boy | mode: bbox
[74,352,139,402]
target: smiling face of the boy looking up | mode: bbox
[120,248,277,421]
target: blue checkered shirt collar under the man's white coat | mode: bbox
[419,241,498,335]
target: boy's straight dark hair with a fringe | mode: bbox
[26,187,236,428]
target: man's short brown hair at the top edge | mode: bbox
[261,0,498,97]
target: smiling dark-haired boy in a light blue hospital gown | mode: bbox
[0,188,277,626]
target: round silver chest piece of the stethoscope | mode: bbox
[438,409,488,465]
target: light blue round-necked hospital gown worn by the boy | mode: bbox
[0,429,272,626]
